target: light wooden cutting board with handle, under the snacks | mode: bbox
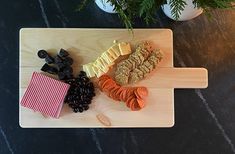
[19,28,208,128]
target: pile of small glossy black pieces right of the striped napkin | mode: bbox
[65,71,95,112]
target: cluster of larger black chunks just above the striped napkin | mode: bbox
[38,49,73,80]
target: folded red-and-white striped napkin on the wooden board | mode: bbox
[21,72,70,118]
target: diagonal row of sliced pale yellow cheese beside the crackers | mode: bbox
[83,42,131,78]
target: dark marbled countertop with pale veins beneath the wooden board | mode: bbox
[0,0,235,154]
